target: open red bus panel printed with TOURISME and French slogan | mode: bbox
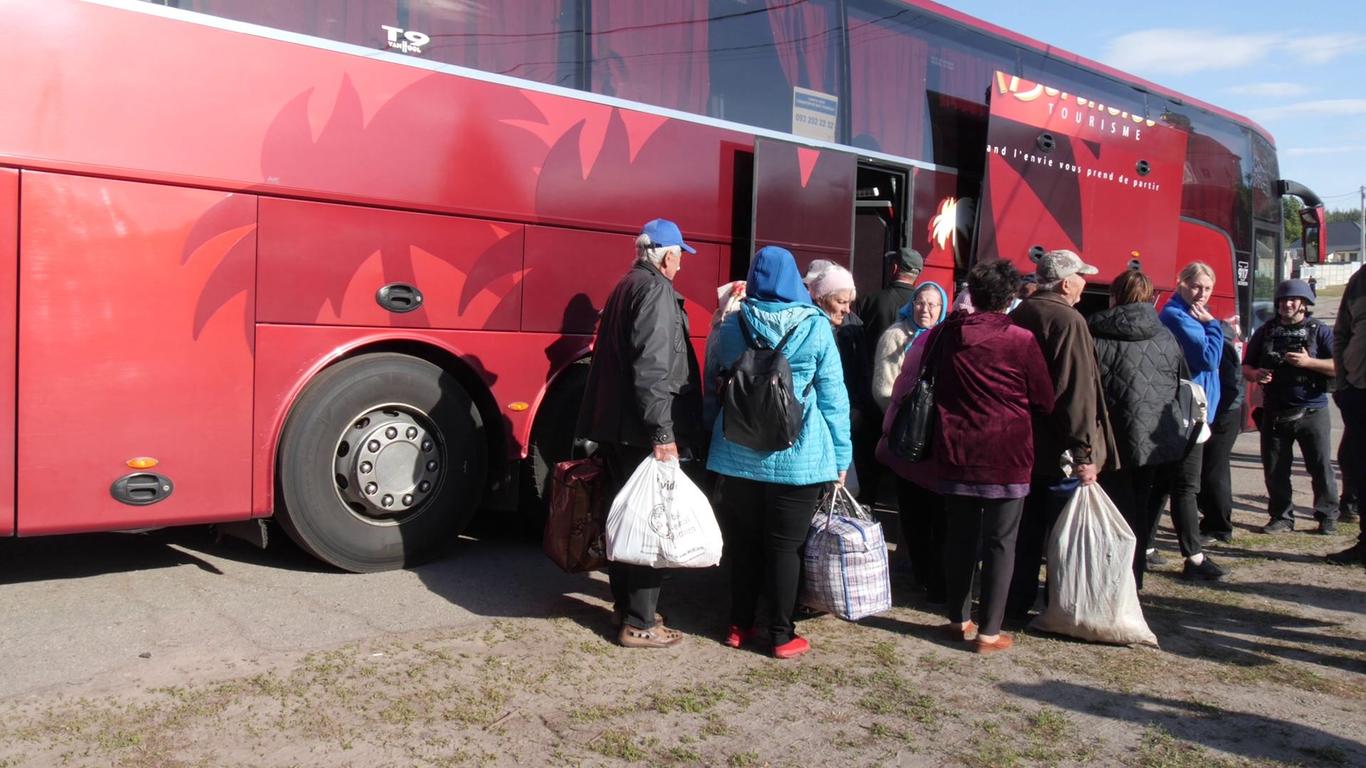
[975,72,1185,312]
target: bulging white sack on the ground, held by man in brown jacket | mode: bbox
[1030,482,1157,645]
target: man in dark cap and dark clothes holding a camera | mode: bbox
[1243,280,1337,534]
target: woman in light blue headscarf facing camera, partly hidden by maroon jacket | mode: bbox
[873,283,948,604]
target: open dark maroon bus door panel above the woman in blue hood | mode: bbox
[750,138,852,281]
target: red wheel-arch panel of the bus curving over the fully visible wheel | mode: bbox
[251,325,564,517]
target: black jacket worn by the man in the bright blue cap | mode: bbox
[576,261,702,450]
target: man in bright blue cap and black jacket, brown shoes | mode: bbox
[576,219,705,648]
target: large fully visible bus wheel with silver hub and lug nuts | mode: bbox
[277,353,488,573]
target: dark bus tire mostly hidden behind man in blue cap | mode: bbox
[519,359,589,536]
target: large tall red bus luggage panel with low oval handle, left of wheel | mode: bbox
[18,172,255,536]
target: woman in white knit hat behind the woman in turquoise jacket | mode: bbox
[803,260,882,503]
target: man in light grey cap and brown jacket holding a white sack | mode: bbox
[1005,250,1119,620]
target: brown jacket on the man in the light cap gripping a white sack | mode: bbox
[1011,291,1119,478]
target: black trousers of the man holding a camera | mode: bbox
[1261,407,1337,522]
